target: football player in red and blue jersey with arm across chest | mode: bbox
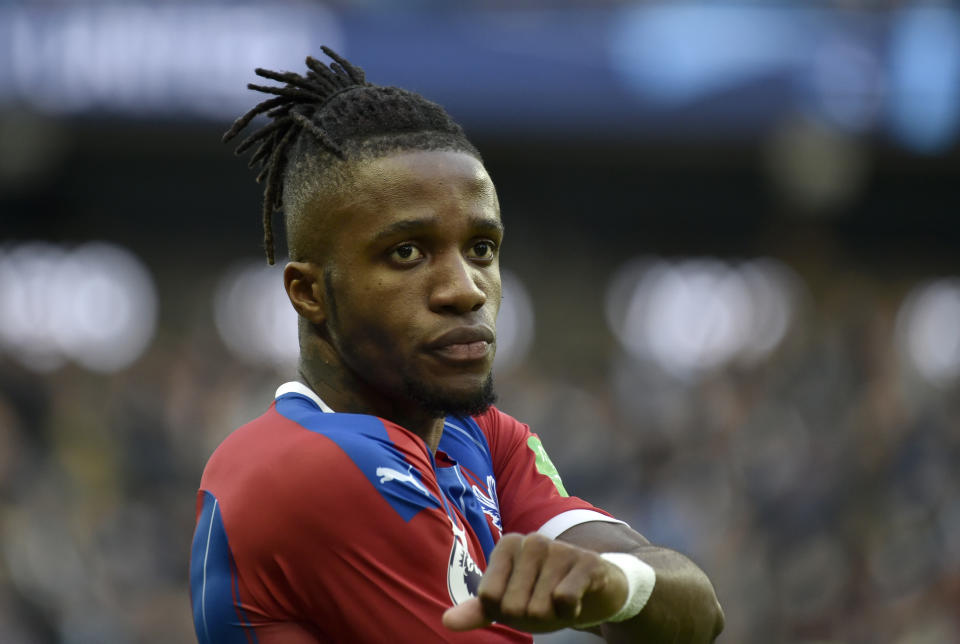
[190,48,723,644]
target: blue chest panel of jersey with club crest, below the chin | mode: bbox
[437,417,500,561]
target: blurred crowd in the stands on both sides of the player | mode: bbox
[0,247,960,644]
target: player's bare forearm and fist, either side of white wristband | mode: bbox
[444,522,724,644]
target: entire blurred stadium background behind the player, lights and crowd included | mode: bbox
[0,0,960,644]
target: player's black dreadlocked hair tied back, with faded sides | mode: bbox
[223,47,480,264]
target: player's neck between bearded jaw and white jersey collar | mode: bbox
[299,342,444,453]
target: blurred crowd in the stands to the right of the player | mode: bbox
[510,264,960,644]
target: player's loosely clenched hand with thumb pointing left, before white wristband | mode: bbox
[443,533,628,633]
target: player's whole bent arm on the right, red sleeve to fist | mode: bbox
[456,408,723,644]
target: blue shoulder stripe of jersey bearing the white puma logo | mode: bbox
[276,393,444,521]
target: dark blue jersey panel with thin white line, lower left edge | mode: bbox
[190,491,257,644]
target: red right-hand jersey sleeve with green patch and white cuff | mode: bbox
[475,407,623,538]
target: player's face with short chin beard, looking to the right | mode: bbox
[310,151,503,414]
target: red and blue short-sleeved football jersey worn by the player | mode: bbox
[190,383,615,644]
